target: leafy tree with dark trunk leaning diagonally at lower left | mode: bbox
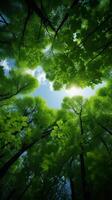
[0,97,56,198]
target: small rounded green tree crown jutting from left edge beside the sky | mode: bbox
[0,68,38,102]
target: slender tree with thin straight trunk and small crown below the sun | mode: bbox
[63,97,89,200]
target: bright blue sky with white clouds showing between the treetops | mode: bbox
[0,59,104,109]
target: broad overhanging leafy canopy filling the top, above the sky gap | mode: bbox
[0,0,112,89]
